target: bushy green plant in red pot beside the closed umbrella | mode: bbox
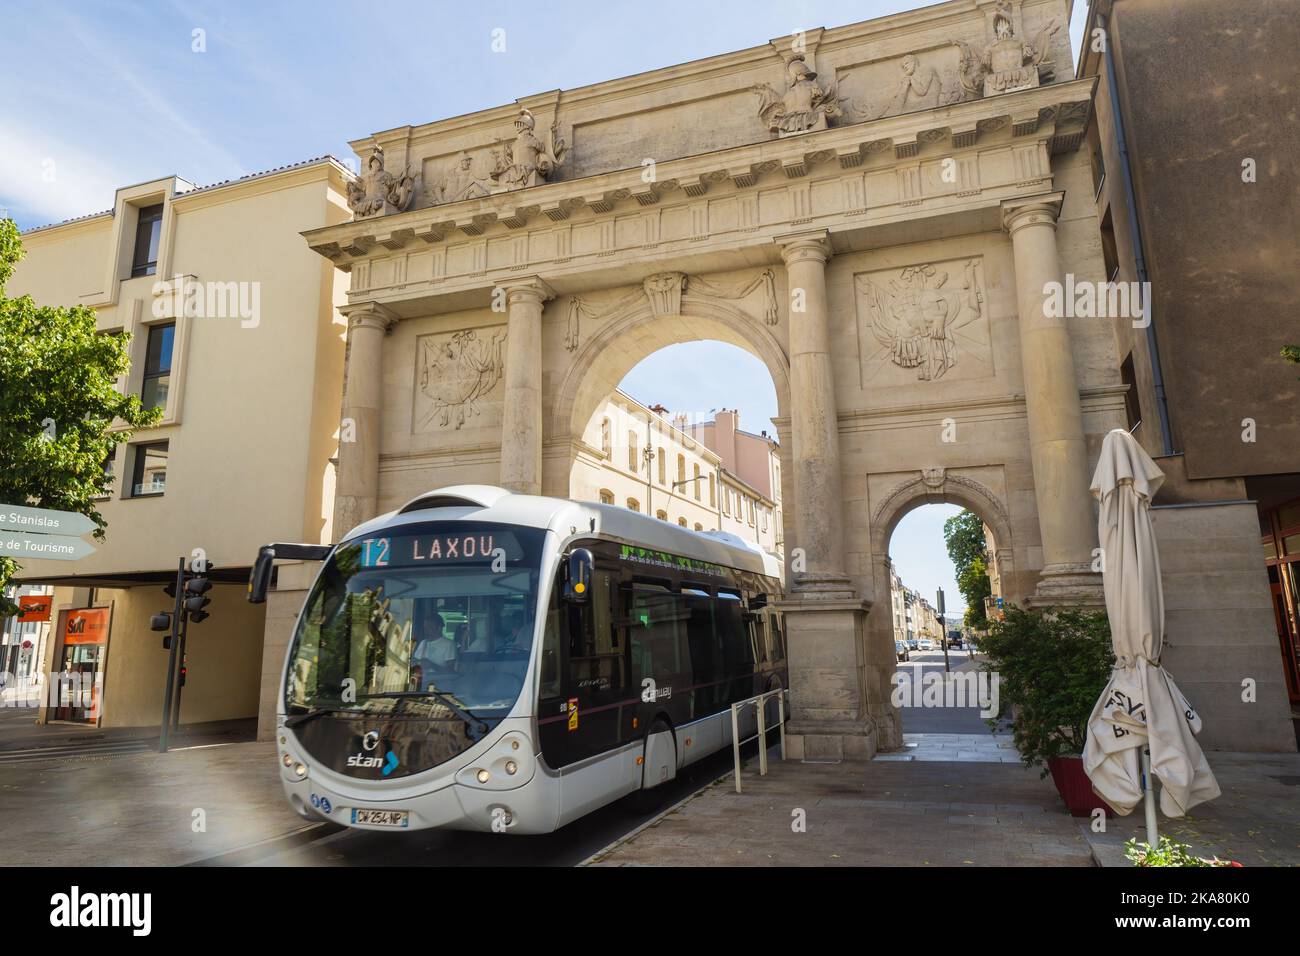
[982,605,1114,817]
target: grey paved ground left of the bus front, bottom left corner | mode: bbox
[0,741,313,866]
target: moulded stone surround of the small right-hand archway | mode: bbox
[867,467,1018,750]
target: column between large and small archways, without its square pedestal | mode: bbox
[781,233,848,589]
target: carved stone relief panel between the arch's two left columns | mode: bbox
[412,328,506,432]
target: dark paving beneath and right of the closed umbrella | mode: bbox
[1080,750,1300,866]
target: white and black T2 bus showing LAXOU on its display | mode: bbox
[248,485,788,834]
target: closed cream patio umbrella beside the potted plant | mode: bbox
[1083,428,1219,845]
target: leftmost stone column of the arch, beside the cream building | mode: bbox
[333,303,397,541]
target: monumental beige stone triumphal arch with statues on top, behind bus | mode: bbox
[307,0,1125,760]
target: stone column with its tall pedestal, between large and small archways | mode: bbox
[777,232,889,762]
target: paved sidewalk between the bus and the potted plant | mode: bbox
[590,750,1093,866]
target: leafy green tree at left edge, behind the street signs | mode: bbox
[0,219,163,615]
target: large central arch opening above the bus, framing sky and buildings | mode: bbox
[547,294,793,567]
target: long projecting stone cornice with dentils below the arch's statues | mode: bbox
[304,78,1096,274]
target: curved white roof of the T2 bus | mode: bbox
[345,485,785,581]
